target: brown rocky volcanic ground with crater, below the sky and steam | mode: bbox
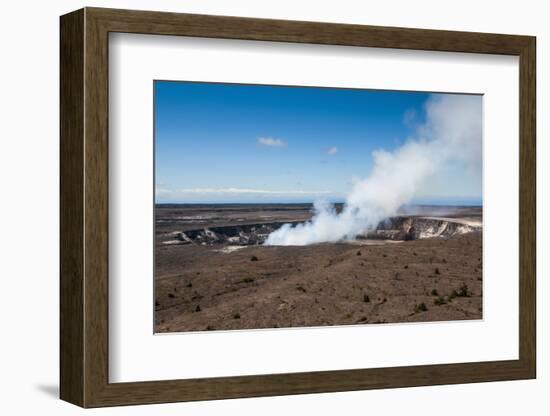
[155,204,482,332]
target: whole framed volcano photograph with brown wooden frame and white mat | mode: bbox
[60,8,536,407]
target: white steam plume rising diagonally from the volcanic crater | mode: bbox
[265,94,482,246]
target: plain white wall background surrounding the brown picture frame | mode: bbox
[0,0,550,416]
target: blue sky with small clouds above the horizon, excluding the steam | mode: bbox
[155,81,481,203]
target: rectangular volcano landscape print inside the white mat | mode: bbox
[153,81,483,333]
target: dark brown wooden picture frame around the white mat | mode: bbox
[60,8,536,407]
